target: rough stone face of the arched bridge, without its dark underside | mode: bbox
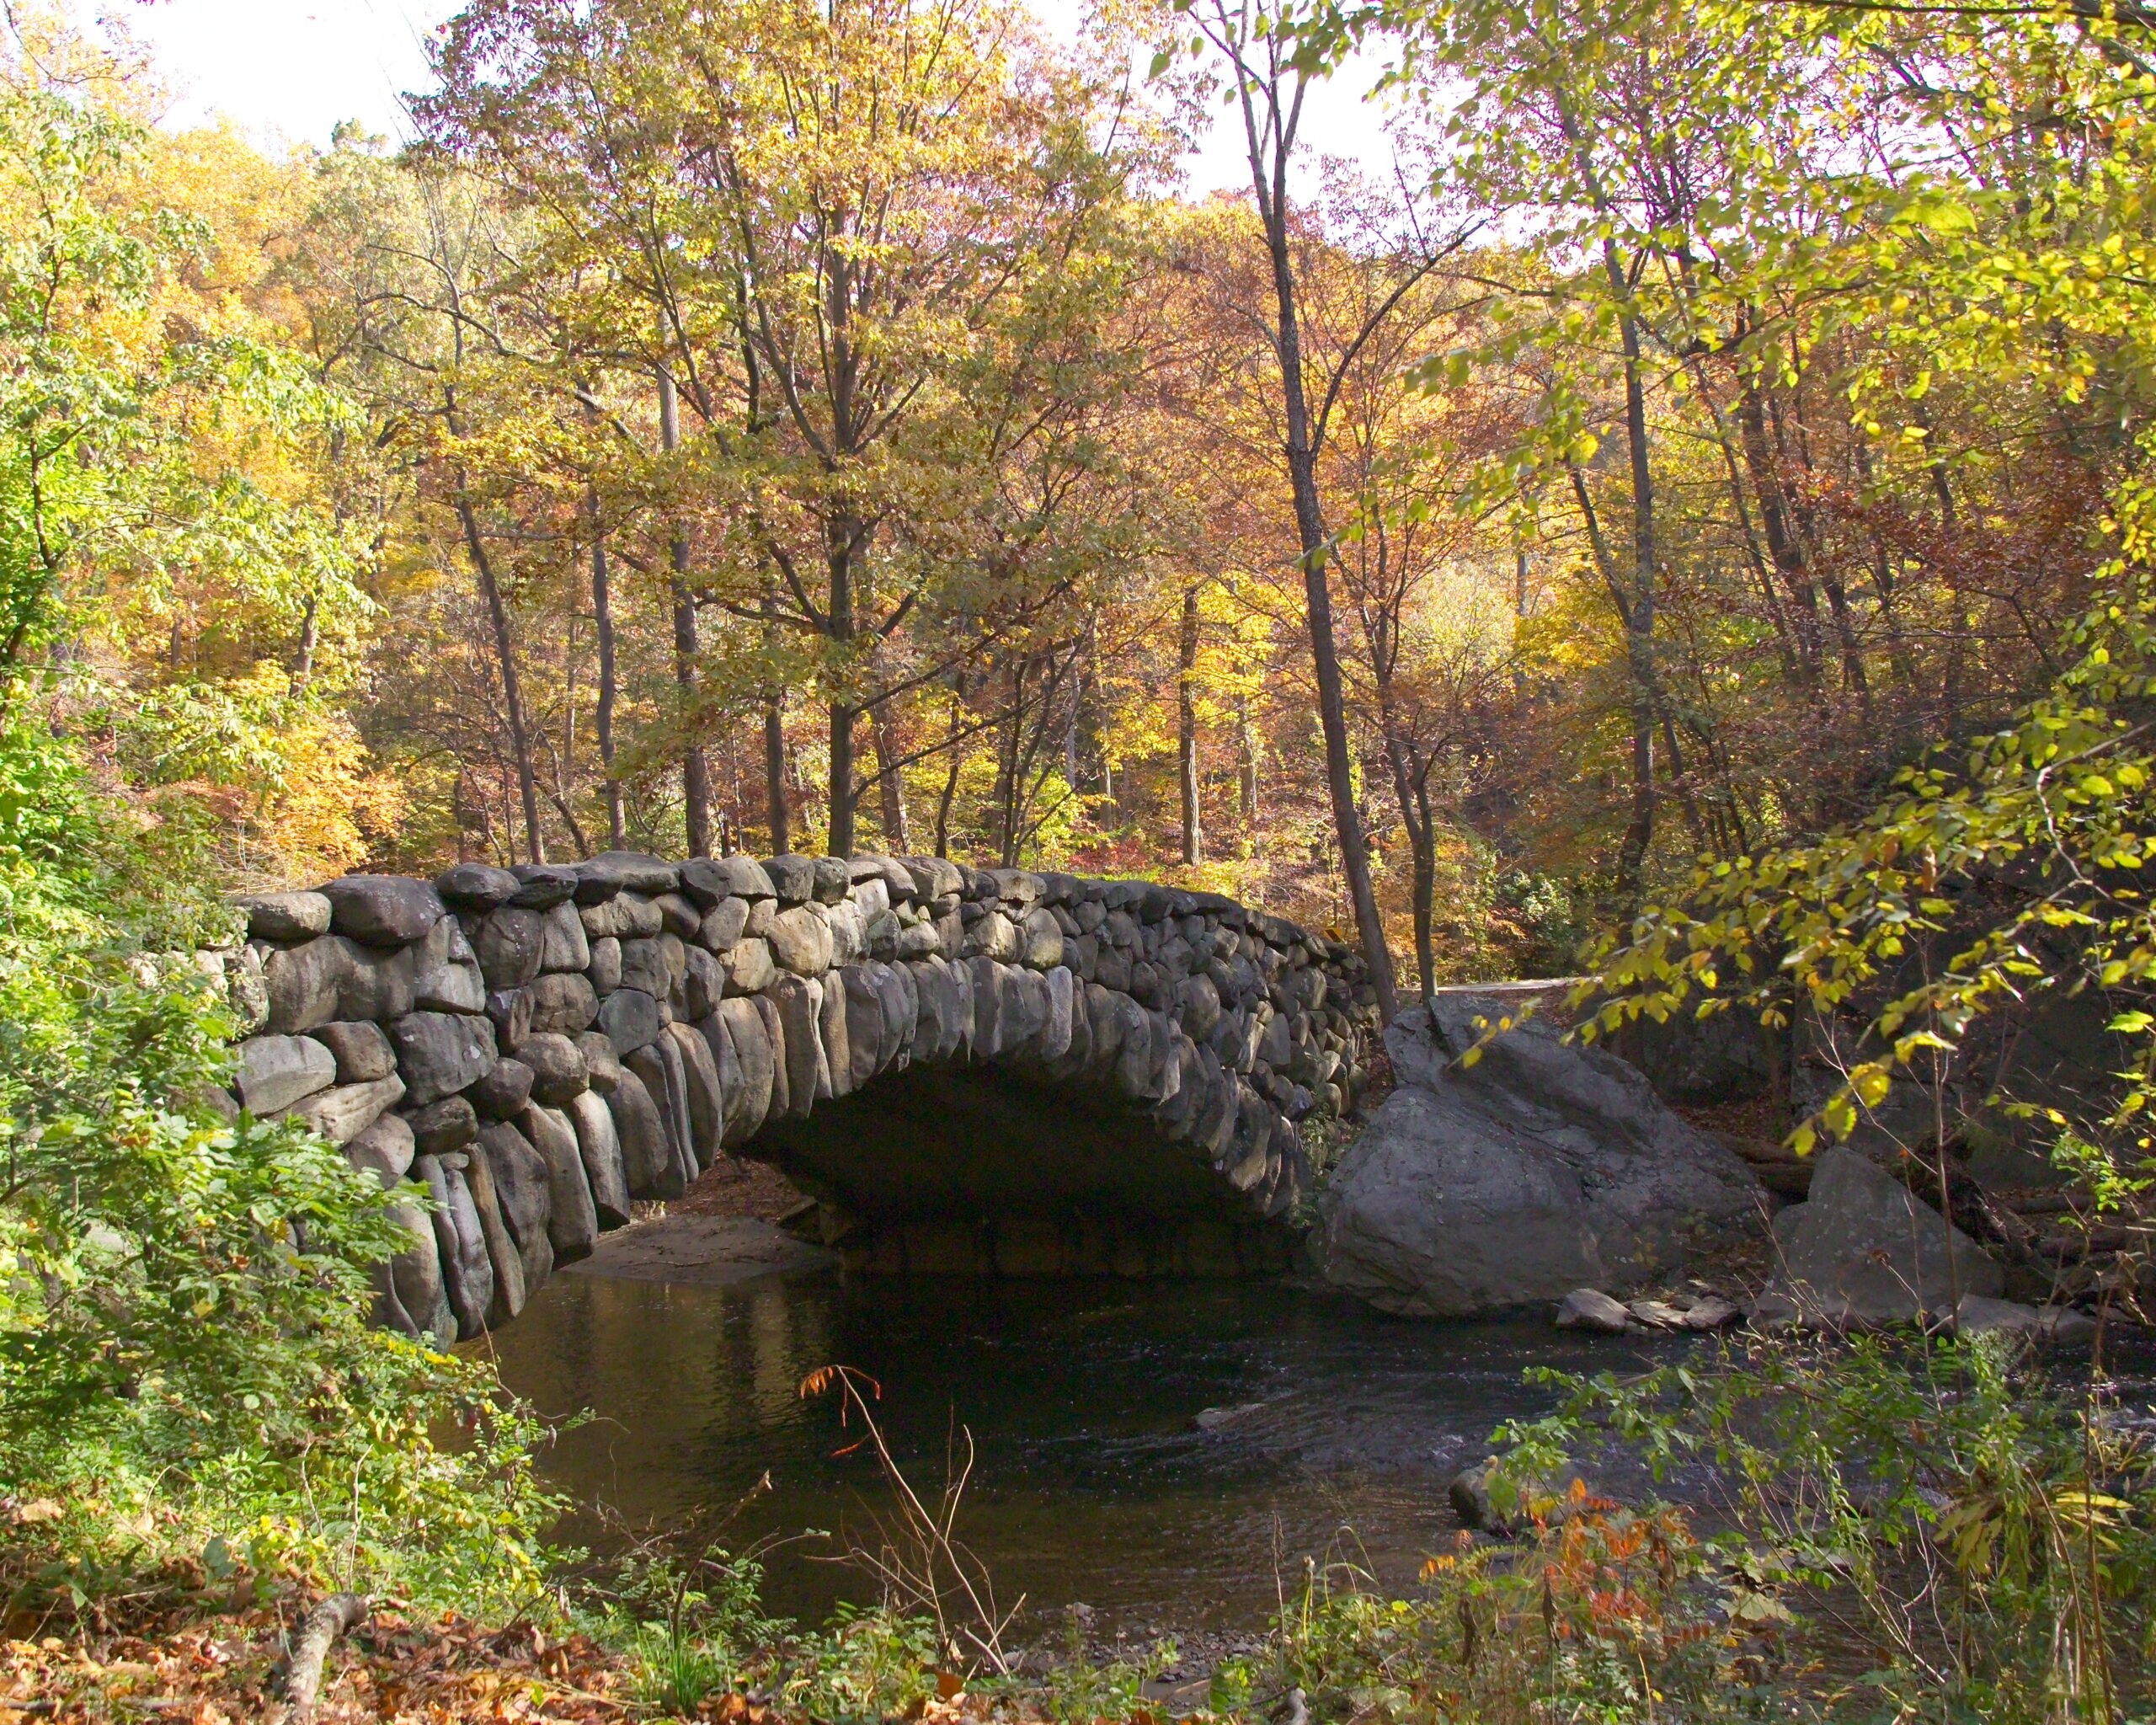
[194,852,1374,1337]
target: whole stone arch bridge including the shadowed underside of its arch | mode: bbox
[205,852,1375,1337]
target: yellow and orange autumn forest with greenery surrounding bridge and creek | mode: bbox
[0,0,2156,1725]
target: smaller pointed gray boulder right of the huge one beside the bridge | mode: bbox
[1753,1145,2005,1328]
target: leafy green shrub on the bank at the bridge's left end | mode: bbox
[0,720,554,1613]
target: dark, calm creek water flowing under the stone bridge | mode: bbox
[496,1272,1688,1634]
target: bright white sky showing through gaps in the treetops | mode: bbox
[104,0,1390,194]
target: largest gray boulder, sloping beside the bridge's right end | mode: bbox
[1320,996,1762,1317]
